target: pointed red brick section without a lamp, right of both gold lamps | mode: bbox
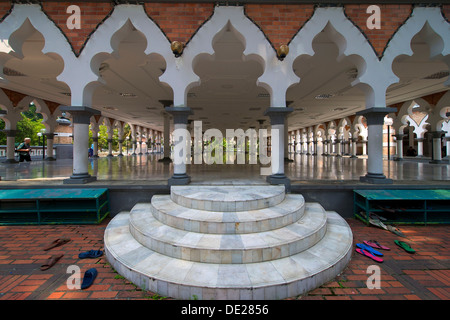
[345,4,412,56]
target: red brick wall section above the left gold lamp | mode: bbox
[145,3,214,43]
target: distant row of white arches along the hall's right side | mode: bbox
[288,91,450,160]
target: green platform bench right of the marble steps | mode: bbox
[353,189,450,224]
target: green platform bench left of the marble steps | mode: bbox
[0,189,110,225]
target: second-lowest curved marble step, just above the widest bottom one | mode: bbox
[130,203,327,264]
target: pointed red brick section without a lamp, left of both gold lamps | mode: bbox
[42,1,113,54]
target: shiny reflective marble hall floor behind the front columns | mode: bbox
[0,154,450,184]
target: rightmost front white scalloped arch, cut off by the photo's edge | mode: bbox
[381,7,450,88]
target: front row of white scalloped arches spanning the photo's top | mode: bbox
[0,4,450,108]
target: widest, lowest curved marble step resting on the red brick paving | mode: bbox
[104,212,353,300]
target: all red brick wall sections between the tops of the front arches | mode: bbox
[0,1,450,56]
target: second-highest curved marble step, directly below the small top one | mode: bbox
[149,192,305,234]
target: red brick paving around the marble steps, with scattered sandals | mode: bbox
[0,219,450,300]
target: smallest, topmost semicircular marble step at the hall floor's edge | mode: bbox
[170,185,285,212]
